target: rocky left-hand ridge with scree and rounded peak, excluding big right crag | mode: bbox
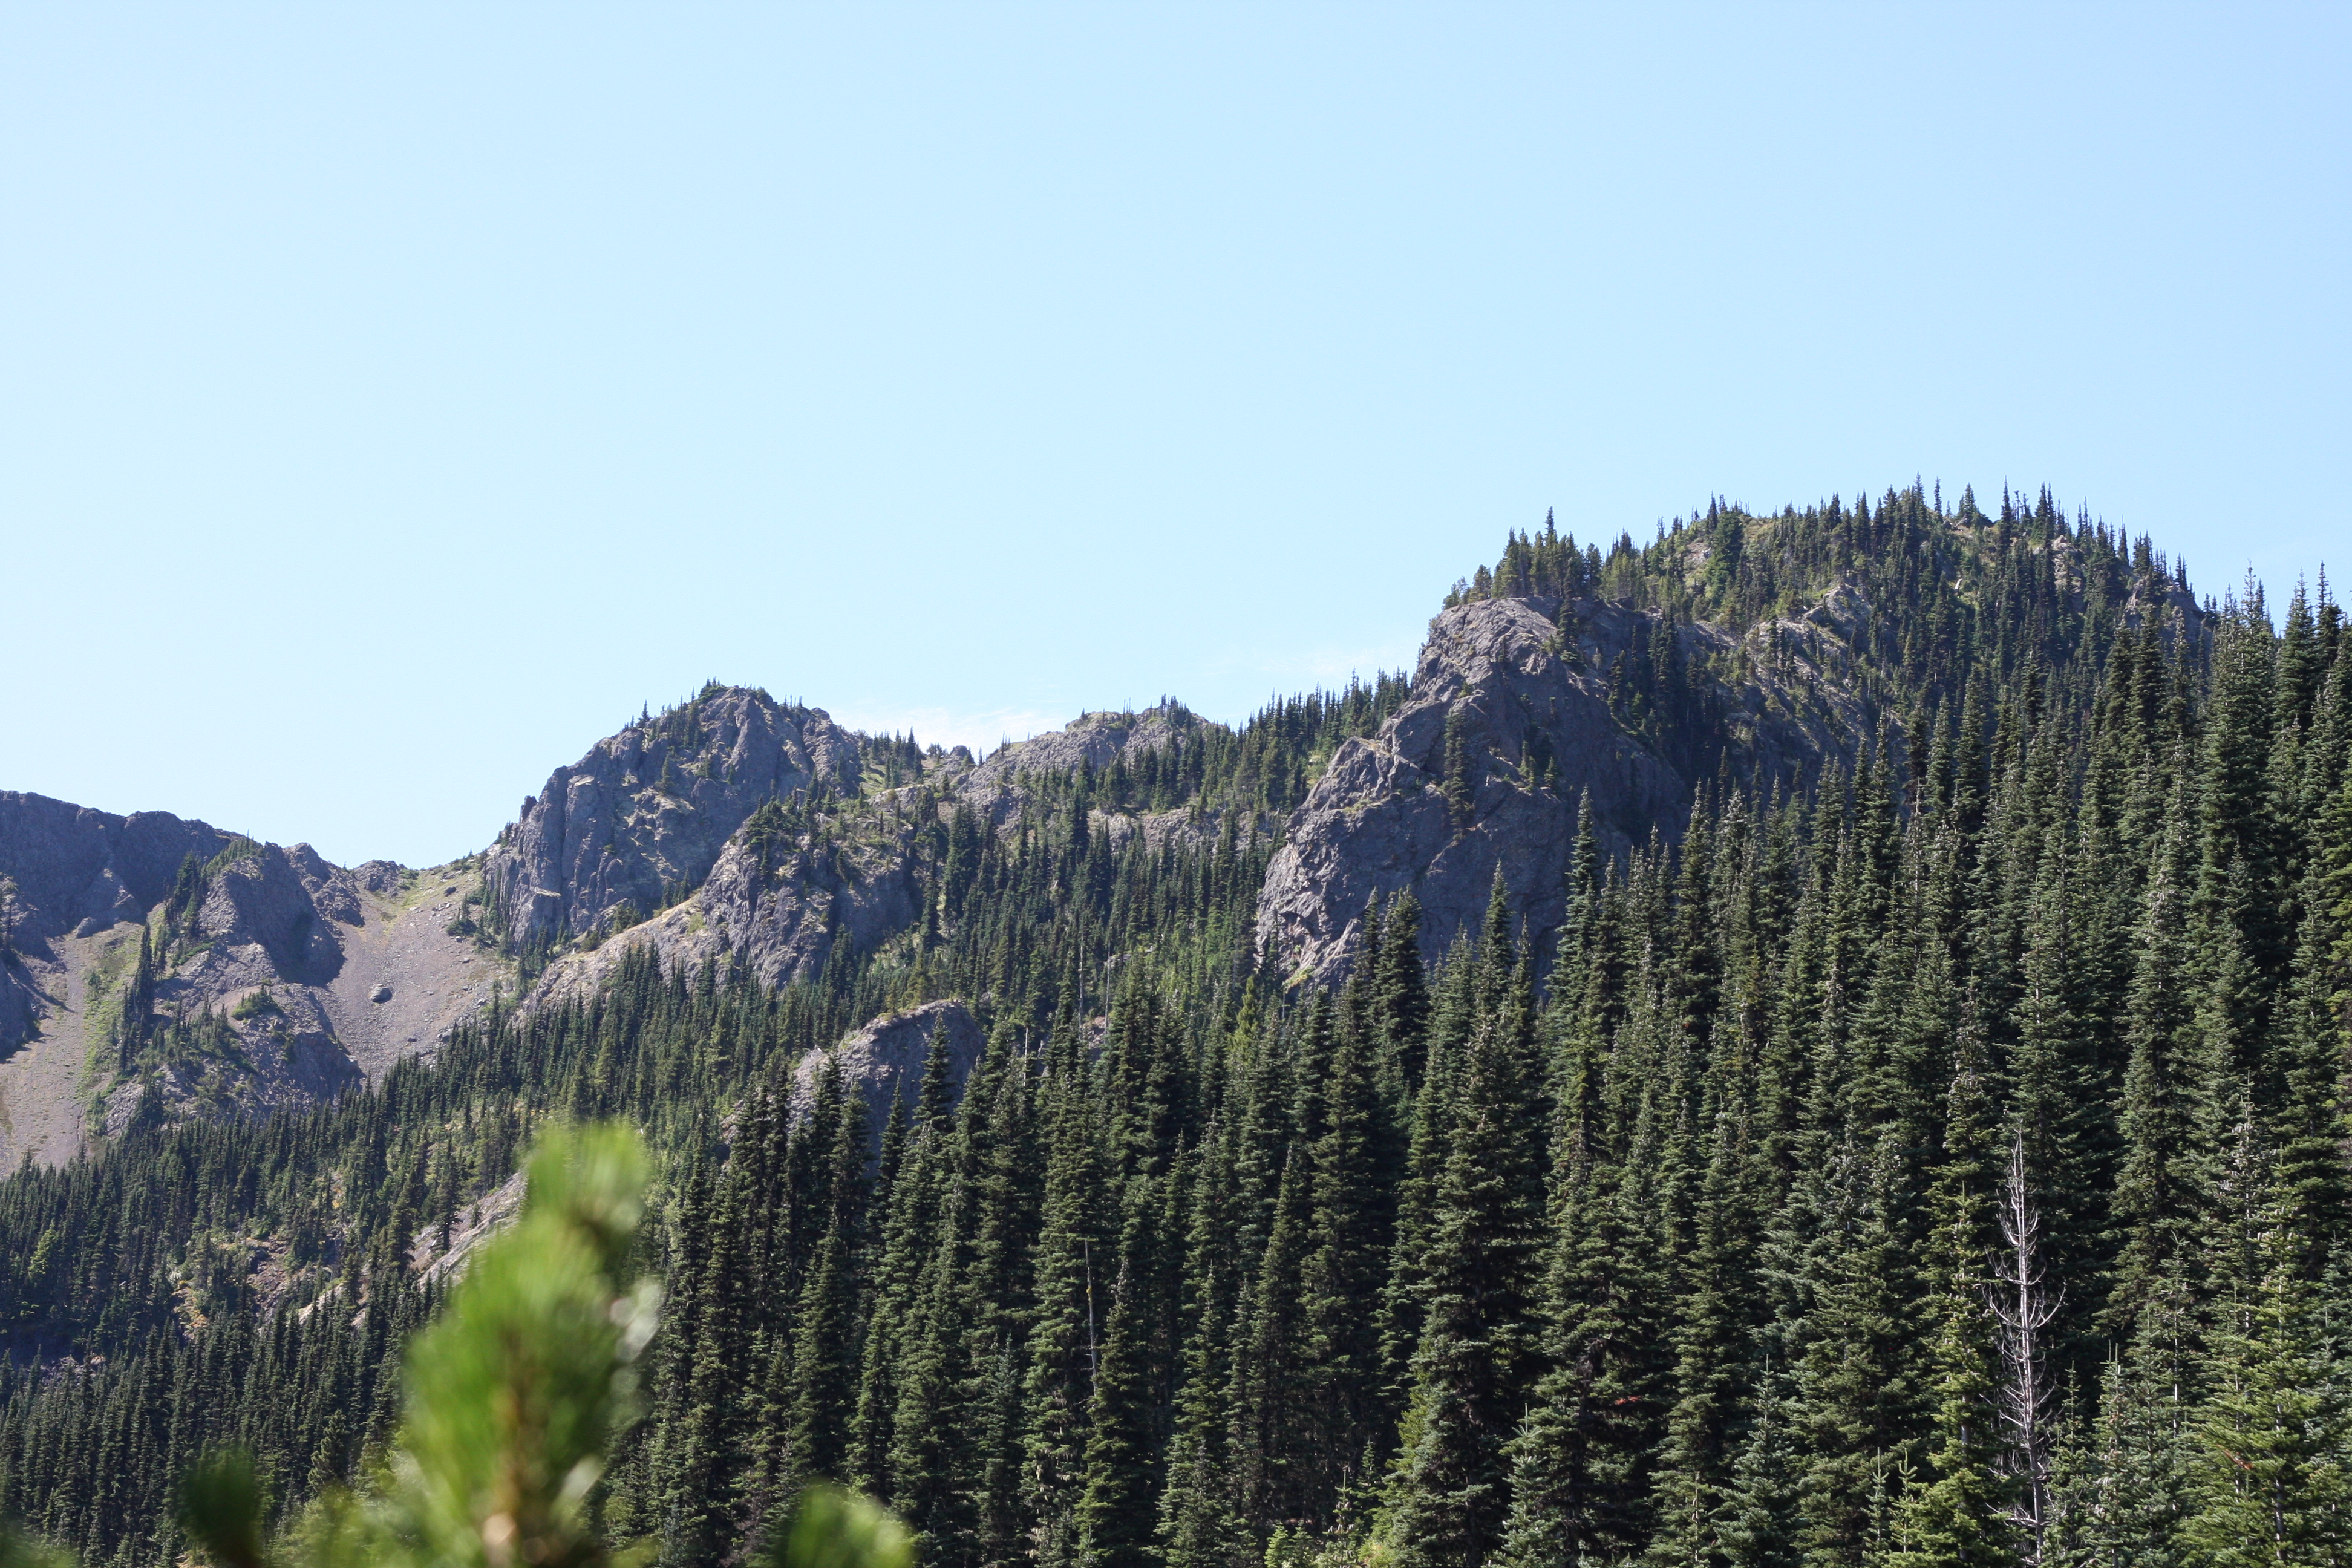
[0,684,1326,1164]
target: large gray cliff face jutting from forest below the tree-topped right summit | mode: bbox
[1258,586,1867,980]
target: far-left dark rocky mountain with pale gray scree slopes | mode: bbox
[0,792,491,1161]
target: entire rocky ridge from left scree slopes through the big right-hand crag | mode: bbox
[0,496,2154,1159]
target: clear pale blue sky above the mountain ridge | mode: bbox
[0,2,2352,863]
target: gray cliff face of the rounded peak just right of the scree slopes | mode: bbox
[482,689,863,942]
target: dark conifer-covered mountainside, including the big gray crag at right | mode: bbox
[0,485,2352,1568]
